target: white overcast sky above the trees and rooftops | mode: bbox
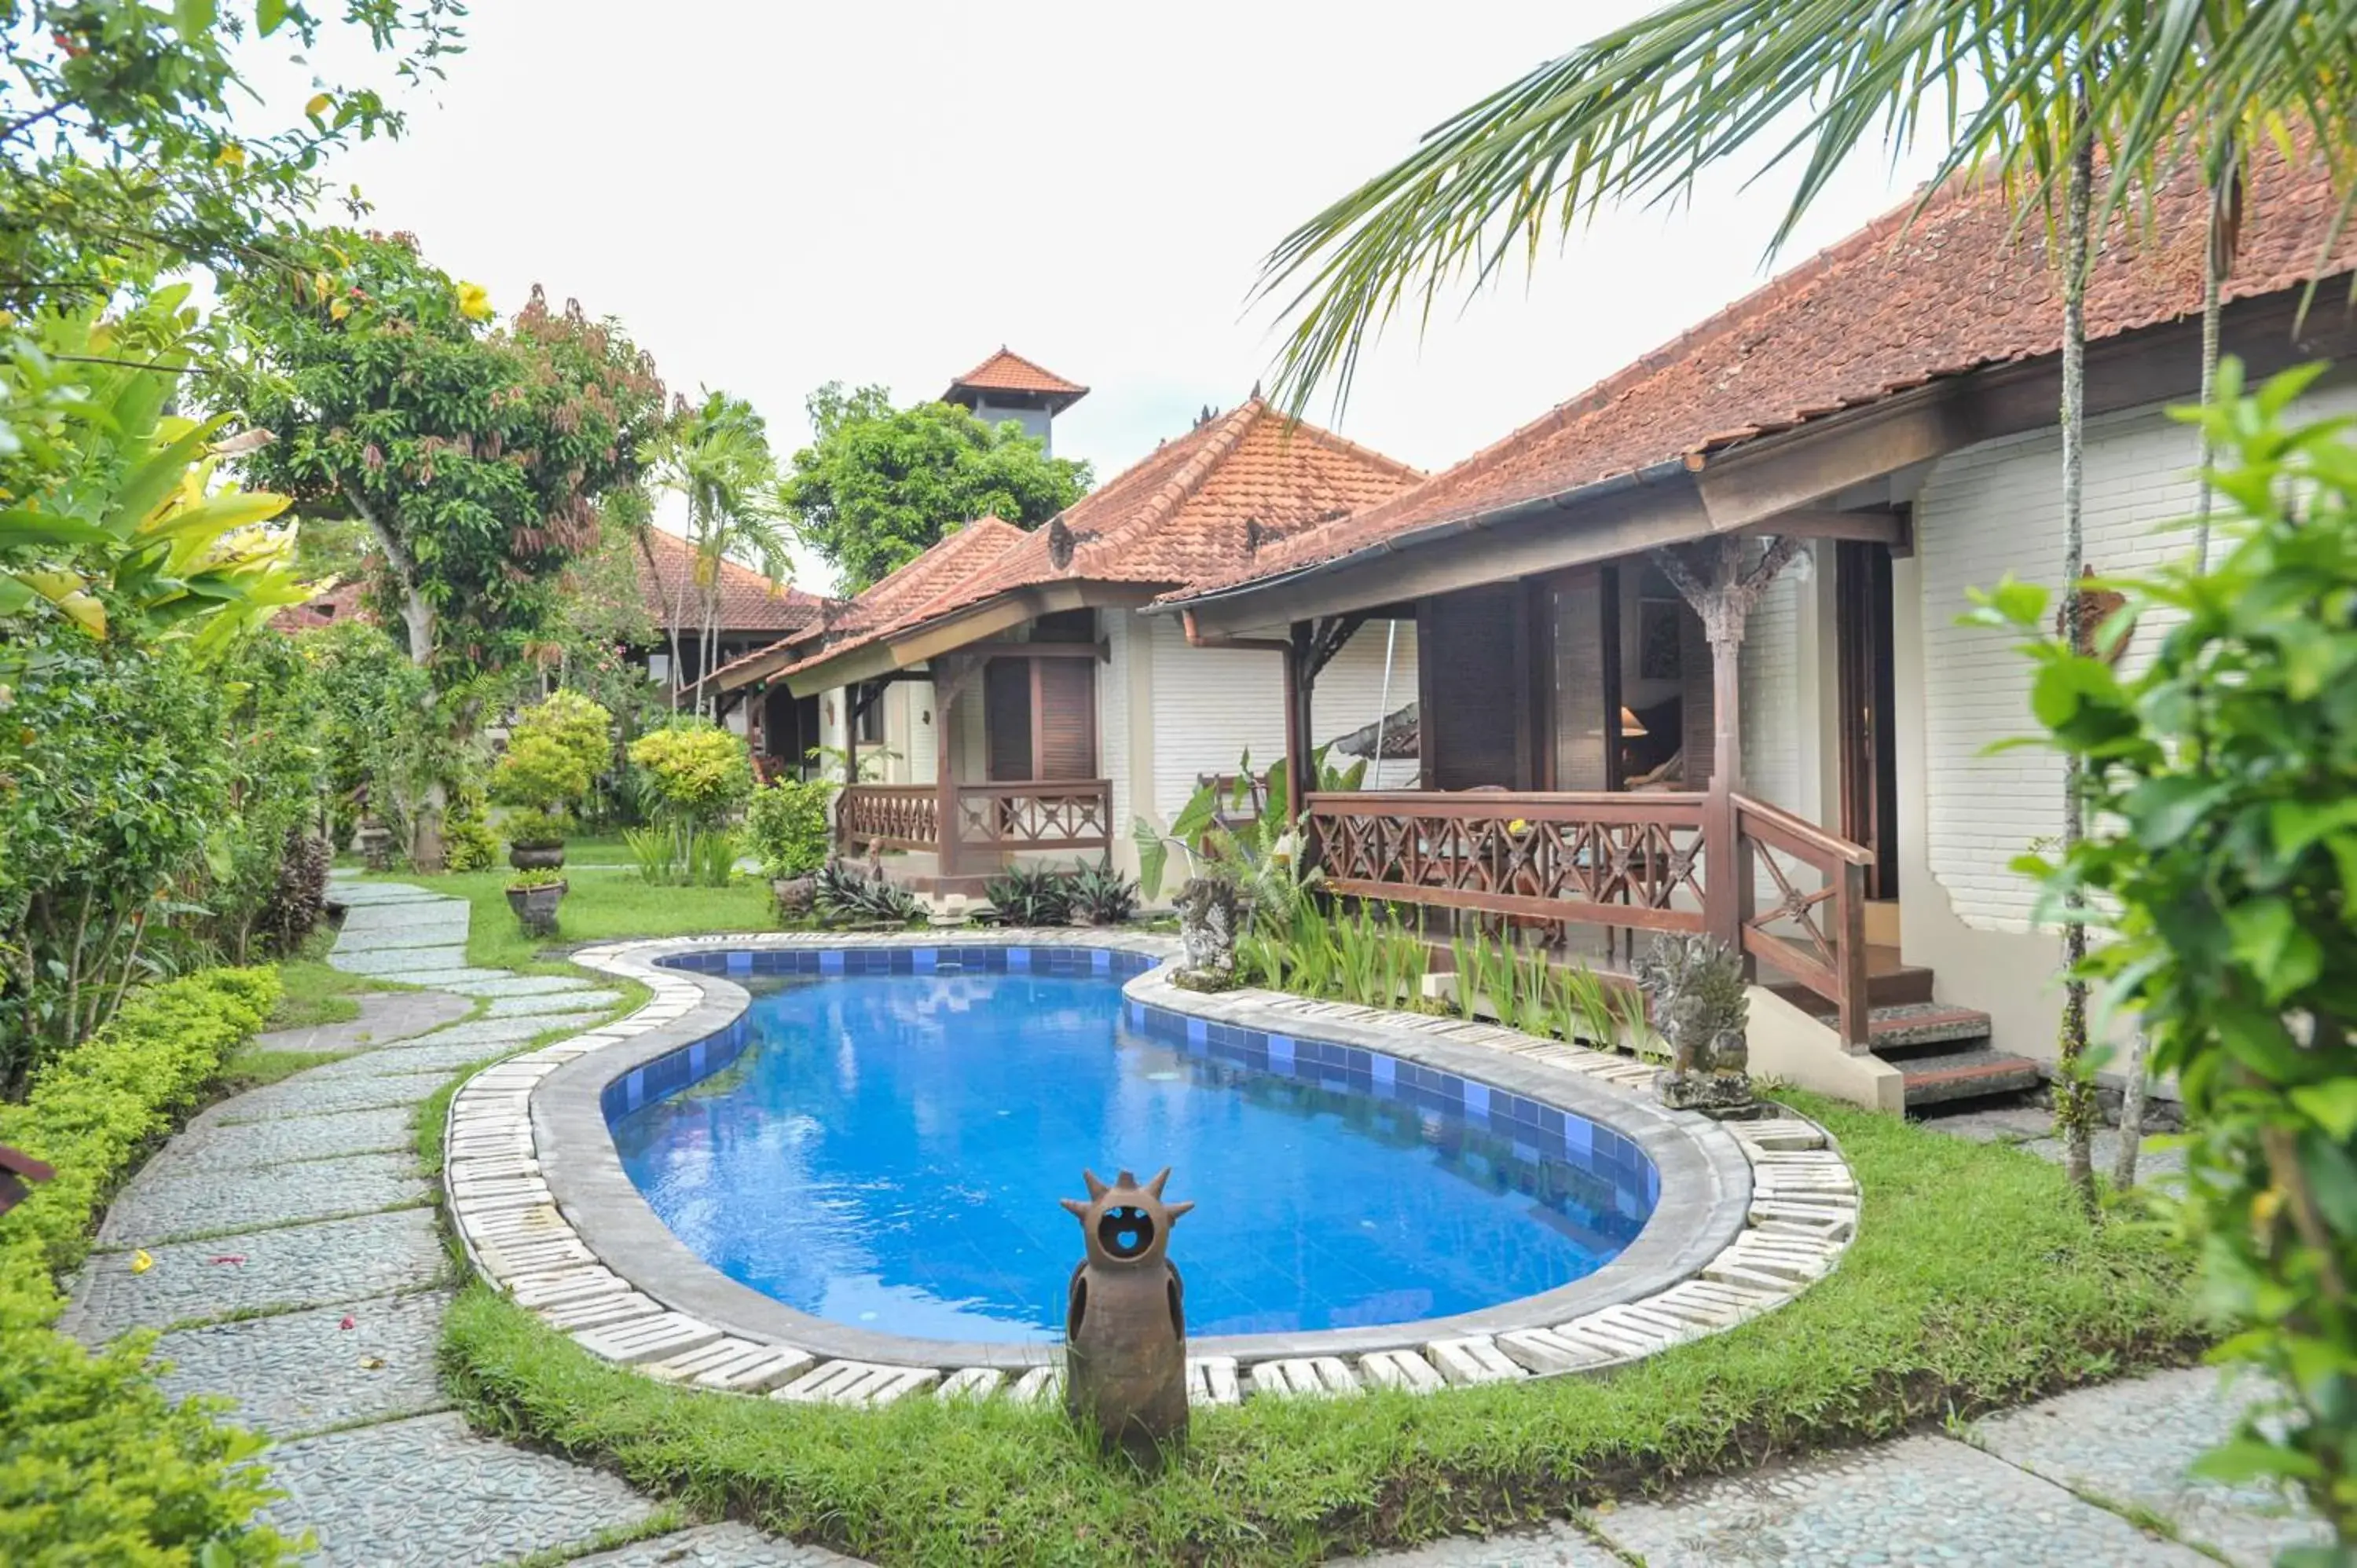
[244,0,1952,587]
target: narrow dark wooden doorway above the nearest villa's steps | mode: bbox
[1834,540,1900,899]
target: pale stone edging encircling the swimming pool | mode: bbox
[443,929,1857,1405]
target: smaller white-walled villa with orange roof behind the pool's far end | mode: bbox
[709,354,1421,892]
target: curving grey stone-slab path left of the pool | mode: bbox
[64,877,846,1568]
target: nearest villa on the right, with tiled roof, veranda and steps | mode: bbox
[1150,144,2357,1108]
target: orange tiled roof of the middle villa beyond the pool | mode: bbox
[797,396,1419,667]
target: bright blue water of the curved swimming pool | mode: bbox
[608,951,1657,1342]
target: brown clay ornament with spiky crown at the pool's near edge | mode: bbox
[1063,1165,1195,1467]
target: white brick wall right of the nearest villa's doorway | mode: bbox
[1900,384,2357,932]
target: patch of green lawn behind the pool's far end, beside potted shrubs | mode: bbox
[368,863,778,974]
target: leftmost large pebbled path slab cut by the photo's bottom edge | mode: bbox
[266,1415,660,1568]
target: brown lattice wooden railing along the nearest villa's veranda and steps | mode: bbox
[1308,790,1871,1050]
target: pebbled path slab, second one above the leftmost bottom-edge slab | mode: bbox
[64,1210,443,1344]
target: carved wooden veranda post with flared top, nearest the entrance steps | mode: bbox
[1652,533,1801,974]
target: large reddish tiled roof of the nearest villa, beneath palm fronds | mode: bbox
[1174,153,2357,596]
